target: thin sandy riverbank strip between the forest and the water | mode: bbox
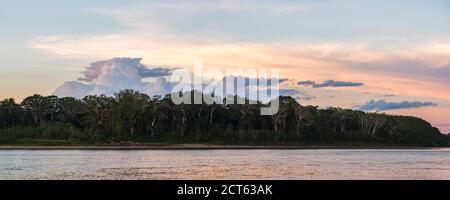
[0,144,438,150]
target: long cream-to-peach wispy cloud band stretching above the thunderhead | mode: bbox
[29,33,450,104]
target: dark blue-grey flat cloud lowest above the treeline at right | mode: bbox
[357,99,437,111]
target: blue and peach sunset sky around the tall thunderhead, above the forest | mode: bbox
[0,0,450,133]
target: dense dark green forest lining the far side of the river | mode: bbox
[0,90,450,146]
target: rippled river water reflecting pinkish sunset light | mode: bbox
[0,149,450,180]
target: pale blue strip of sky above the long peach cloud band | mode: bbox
[0,0,450,42]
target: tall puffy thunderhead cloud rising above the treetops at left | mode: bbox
[54,58,172,98]
